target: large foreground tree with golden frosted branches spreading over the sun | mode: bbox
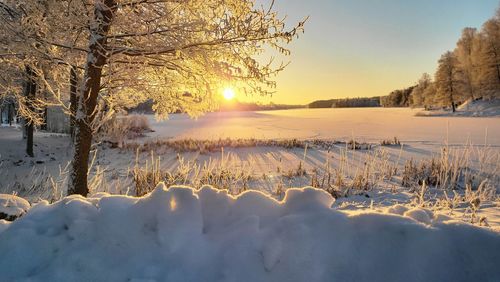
[26,0,303,195]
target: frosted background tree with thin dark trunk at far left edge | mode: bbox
[0,0,86,156]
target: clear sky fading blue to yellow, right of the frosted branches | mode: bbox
[252,0,500,104]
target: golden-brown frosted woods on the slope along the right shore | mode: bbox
[380,9,500,111]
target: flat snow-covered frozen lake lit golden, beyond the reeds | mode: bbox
[149,108,500,146]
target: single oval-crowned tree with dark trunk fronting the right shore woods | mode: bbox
[434,51,462,112]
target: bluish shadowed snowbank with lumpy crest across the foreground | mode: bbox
[0,184,500,281]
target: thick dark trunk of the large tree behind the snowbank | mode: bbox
[68,0,117,196]
